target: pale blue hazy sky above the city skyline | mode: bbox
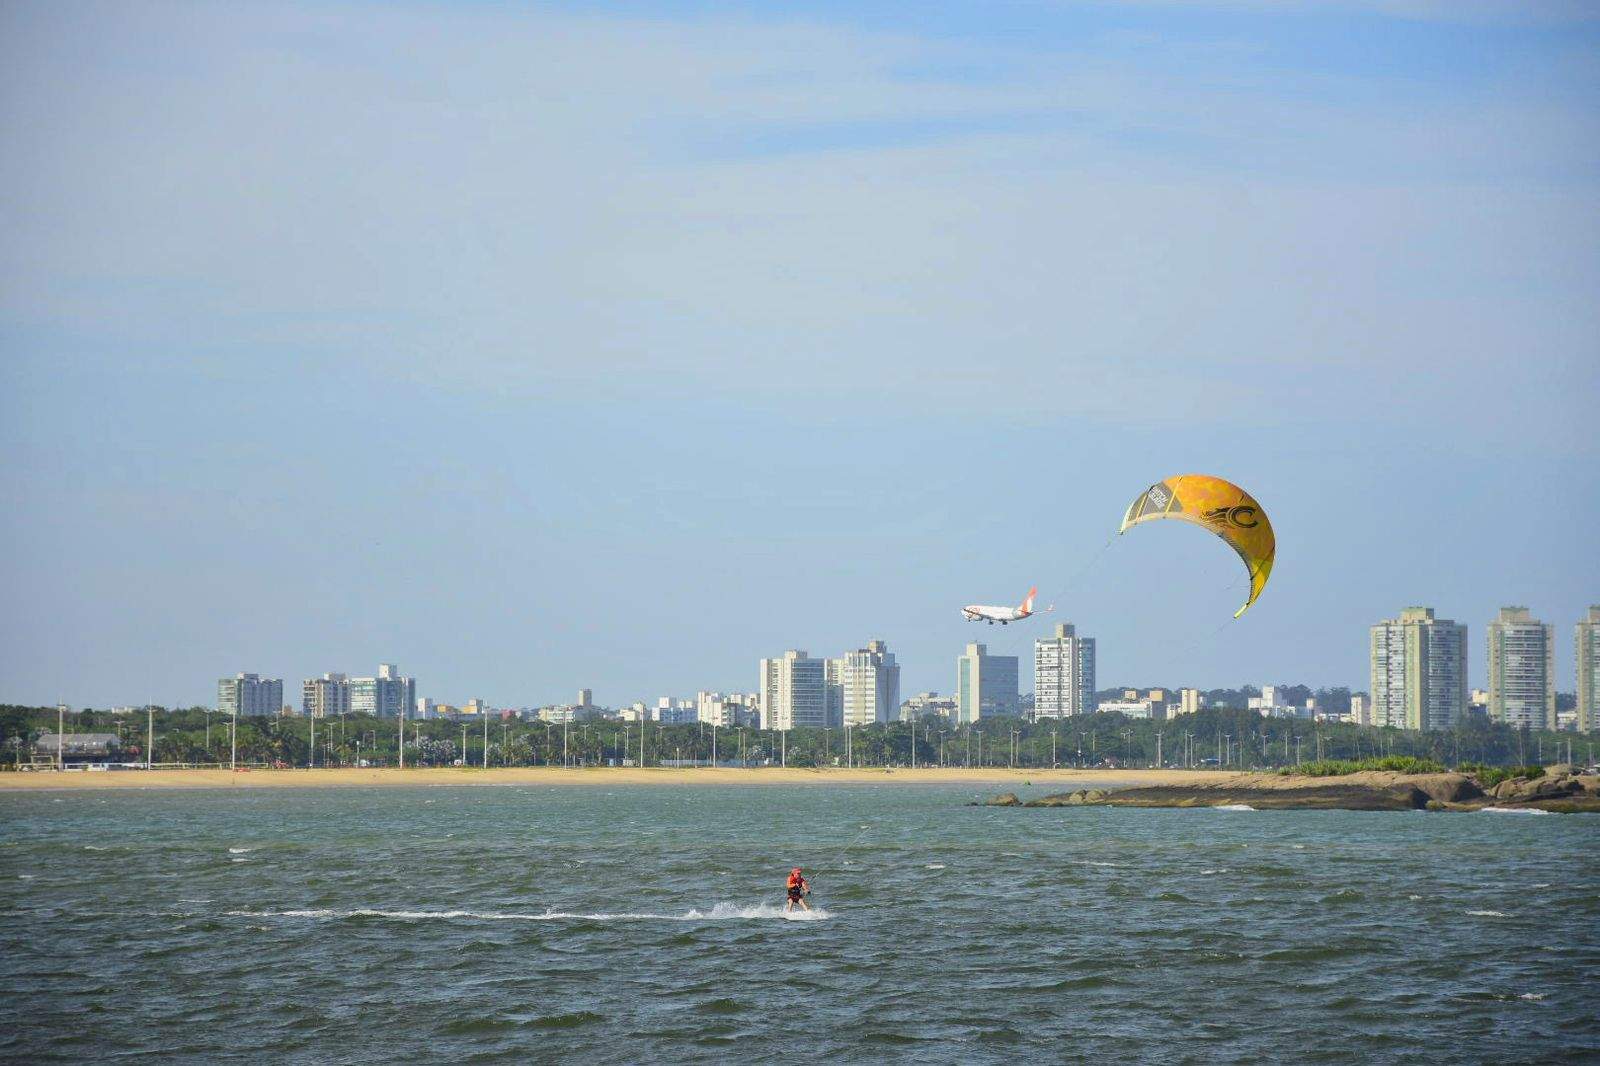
[0,0,1600,706]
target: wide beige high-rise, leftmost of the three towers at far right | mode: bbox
[1371,607,1467,730]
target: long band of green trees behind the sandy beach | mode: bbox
[0,706,1595,770]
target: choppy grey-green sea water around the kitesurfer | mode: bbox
[0,784,1600,1063]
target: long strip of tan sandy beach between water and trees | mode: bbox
[0,767,1235,791]
